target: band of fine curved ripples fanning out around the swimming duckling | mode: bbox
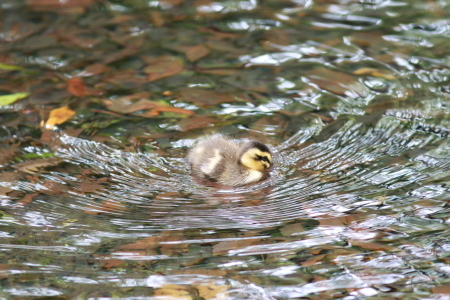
[15,110,442,230]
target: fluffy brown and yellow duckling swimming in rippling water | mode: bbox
[187,134,272,186]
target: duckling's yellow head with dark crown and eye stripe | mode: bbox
[239,141,272,171]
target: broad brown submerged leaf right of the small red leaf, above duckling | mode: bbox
[144,55,184,82]
